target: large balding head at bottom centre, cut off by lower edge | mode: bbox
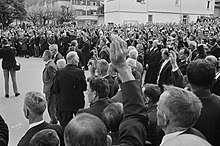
[64,113,107,146]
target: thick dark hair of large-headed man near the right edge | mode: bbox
[186,59,215,87]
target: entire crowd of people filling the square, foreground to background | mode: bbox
[0,16,220,146]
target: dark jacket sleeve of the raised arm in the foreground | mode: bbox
[119,81,148,146]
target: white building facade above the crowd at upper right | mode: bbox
[105,0,215,24]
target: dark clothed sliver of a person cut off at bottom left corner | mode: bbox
[0,116,9,146]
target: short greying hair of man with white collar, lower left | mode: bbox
[24,91,47,115]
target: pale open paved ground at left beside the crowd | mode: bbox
[0,58,88,146]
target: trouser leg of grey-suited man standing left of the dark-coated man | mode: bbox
[46,94,57,123]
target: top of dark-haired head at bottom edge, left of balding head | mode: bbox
[30,129,60,146]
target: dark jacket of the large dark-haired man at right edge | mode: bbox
[194,90,220,146]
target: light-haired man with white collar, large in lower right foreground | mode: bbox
[157,86,205,146]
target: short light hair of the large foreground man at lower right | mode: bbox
[165,86,202,128]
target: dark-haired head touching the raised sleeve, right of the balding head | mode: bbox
[102,103,123,132]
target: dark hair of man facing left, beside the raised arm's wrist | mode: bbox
[89,77,110,99]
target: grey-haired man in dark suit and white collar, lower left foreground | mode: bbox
[17,91,64,146]
